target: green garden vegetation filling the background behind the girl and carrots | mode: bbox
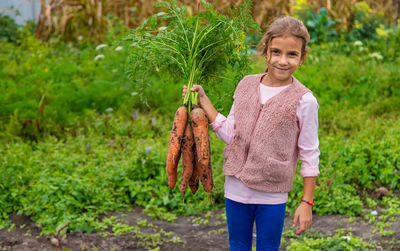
[0,1,400,249]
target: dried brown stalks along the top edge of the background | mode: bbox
[36,0,400,42]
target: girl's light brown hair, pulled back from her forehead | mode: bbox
[260,16,310,61]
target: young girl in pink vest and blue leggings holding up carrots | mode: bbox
[183,16,320,251]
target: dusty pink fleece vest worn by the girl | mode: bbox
[223,73,310,193]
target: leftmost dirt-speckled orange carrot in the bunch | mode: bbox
[167,106,187,189]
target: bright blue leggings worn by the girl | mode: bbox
[225,198,286,251]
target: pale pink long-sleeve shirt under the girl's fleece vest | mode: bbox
[210,80,320,204]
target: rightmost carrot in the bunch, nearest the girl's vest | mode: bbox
[190,107,214,193]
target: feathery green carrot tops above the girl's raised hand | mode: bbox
[127,1,256,111]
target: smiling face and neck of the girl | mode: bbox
[262,36,305,86]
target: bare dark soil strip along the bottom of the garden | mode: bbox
[0,207,400,251]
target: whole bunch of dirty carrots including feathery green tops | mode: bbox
[124,0,259,196]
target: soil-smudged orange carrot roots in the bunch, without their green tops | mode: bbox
[167,105,214,197]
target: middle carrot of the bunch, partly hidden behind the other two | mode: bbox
[179,123,194,197]
